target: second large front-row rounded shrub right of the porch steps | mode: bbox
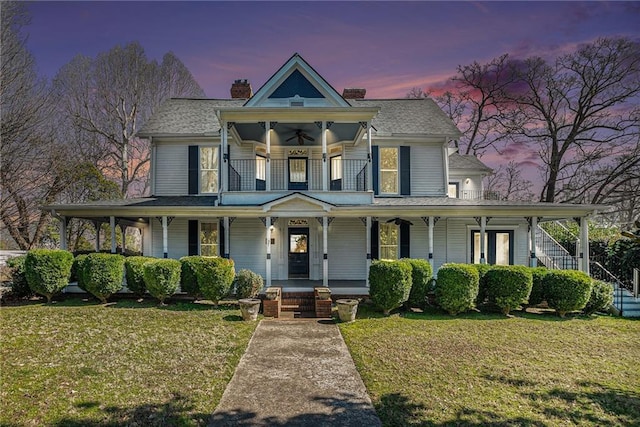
[435,264,480,315]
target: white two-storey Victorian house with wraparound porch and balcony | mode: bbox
[45,54,601,294]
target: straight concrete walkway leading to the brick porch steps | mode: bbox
[211,319,381,427]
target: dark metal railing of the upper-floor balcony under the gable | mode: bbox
[229,159,367,191]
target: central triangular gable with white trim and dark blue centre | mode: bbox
[244,53,349,107]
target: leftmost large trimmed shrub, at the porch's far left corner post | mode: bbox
[24,249,73,303]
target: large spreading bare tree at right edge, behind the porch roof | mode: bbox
[504,39,640,202]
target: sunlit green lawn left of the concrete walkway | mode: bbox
[0,299,256,426]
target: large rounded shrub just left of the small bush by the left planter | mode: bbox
[196,257,236,305]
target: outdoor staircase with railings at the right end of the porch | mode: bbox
[535,225,640,317]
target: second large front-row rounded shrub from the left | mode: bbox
[81,253,124,304]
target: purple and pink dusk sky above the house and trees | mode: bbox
[26,2,640,98]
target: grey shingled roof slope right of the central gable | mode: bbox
[349,98,462,138]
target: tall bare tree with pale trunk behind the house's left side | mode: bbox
[54,43,204,197]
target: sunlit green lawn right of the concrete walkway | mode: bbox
[340,307,640,426]
